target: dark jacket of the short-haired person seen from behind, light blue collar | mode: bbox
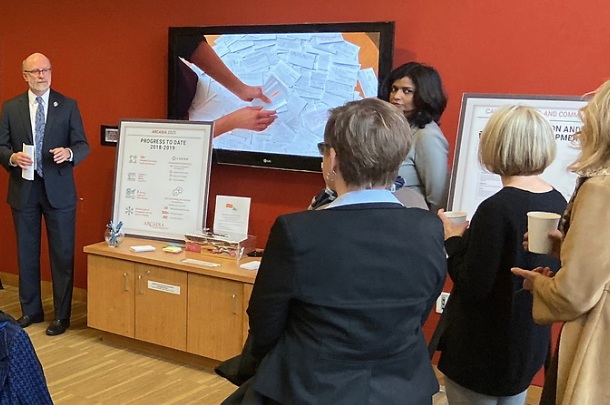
[243,203,446,405]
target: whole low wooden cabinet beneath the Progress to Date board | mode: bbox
[85,239,256,361]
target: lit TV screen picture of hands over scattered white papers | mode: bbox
[176,32,379,157]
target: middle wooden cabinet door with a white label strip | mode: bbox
[135,264,187,351]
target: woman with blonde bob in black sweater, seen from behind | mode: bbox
[438,106,566,405]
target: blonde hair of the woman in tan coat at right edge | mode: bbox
[570,80,610,174]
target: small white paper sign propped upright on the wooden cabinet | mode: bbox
[213,195,250,236]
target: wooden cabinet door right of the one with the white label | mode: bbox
[187,274,244,361]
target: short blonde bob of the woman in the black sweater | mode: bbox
[479,105,557,176]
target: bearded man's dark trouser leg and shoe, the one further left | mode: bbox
[12,178,44,327]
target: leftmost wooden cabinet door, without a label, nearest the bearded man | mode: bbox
[87,255,135,337]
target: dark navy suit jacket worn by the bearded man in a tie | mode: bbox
[0,90,89,210]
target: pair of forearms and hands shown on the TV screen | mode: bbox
[183,40,277,137]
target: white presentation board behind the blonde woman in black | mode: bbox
[447,94,587,218]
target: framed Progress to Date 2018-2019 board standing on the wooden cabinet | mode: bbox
[112,120,213,240]
